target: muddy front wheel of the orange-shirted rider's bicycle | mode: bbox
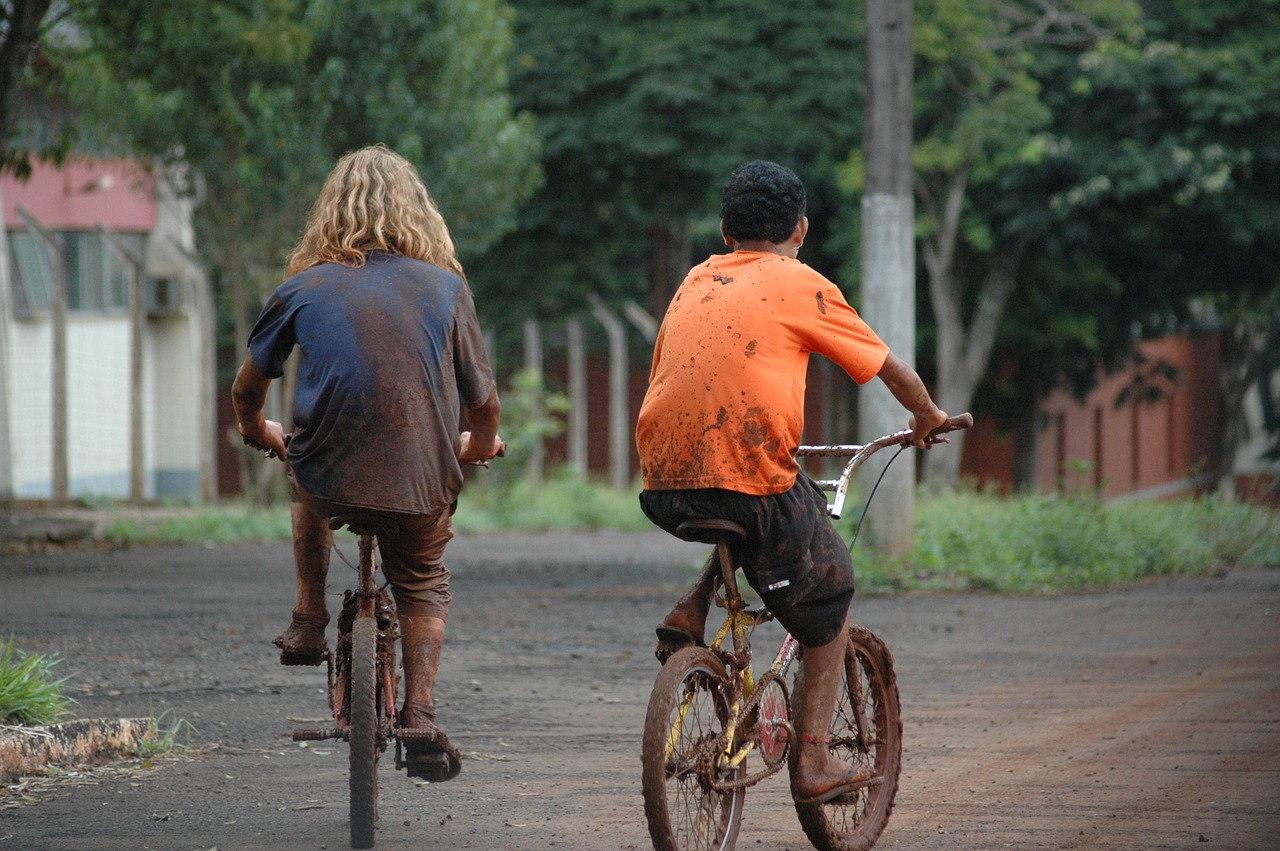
[791,626,902,851]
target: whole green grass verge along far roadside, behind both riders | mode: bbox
[92,481,1280,594]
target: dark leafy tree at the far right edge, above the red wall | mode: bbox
[1008,0,1280,491]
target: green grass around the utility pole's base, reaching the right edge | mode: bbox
[855,491,1280,594]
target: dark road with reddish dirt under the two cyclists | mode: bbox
[0,532,1280,851]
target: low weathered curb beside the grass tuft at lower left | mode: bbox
[0,718,152,783]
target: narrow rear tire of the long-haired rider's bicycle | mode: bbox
[351,617,379,848]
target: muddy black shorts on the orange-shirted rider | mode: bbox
[640,473,854,648]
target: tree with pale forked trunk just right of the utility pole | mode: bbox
[846,0,1137,486]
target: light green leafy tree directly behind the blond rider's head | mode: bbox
[61,0,538,499]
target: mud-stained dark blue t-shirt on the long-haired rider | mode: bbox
[248,252,494,514]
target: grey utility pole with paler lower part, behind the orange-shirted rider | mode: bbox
[858,0,915,557]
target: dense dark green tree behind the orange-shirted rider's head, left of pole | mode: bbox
[477,0,861,335]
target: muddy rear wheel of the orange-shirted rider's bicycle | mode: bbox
[640,648,746,851]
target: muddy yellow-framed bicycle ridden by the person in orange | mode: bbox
[641,413,973,851]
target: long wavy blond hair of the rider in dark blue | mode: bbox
[284,145,463,278]
